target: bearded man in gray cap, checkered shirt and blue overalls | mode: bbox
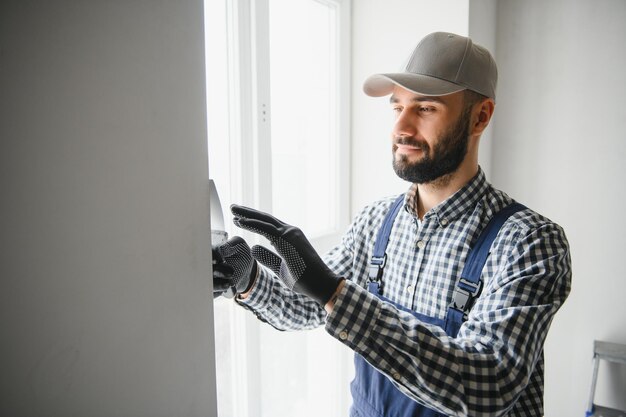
[214,33,571,417]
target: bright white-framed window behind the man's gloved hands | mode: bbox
[205,0,352,417]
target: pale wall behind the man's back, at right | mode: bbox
[493,0,626,417]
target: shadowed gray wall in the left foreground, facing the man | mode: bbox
[0,0,216,417]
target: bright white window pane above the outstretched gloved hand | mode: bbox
[269,0,339,237]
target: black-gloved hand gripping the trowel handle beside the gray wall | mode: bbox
[212,236,257,298]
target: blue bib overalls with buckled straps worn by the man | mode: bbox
[350,194,525,417]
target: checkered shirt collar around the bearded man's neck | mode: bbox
[404,167,491,226]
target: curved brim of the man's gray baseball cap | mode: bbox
[363,73,466,97]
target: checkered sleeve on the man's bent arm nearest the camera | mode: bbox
[326,219,571,416]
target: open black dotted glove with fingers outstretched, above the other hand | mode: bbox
[230,204,342,307]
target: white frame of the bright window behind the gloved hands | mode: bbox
[205,0,352,417]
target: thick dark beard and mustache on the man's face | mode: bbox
[393,106,471,184]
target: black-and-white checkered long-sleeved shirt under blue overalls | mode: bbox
[240,167,571,416]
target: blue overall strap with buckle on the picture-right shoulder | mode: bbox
[448,203,526,320]
